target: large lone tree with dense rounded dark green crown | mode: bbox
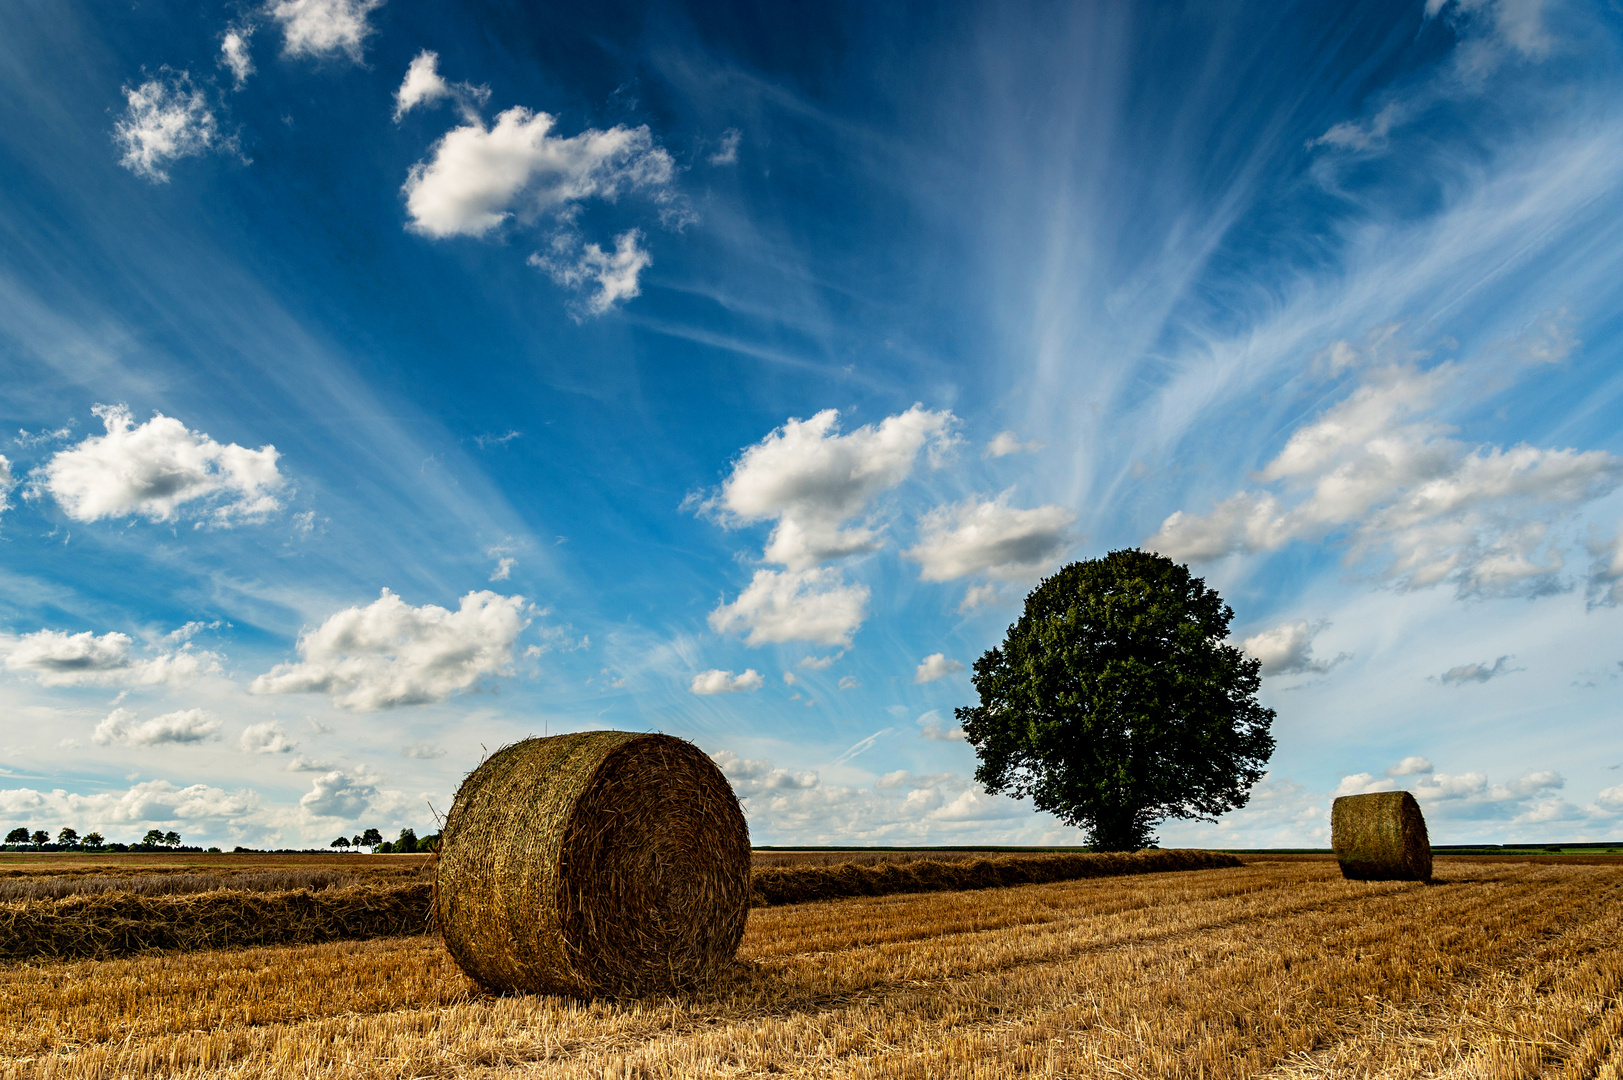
[956,551,1274,851]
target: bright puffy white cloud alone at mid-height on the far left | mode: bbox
[34,404,286,526]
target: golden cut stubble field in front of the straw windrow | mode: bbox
[0,859,1623,1080]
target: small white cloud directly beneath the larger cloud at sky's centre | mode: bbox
[709,567,868,646]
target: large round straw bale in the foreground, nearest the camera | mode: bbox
[435,731,750,994]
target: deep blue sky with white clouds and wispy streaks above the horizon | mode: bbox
[0,0,1623,846]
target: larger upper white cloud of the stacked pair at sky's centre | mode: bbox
[703,404,956,570]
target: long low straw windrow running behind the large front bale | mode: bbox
[0,851,1240,960]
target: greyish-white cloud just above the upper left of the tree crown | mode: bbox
[902,492,1076,581]
